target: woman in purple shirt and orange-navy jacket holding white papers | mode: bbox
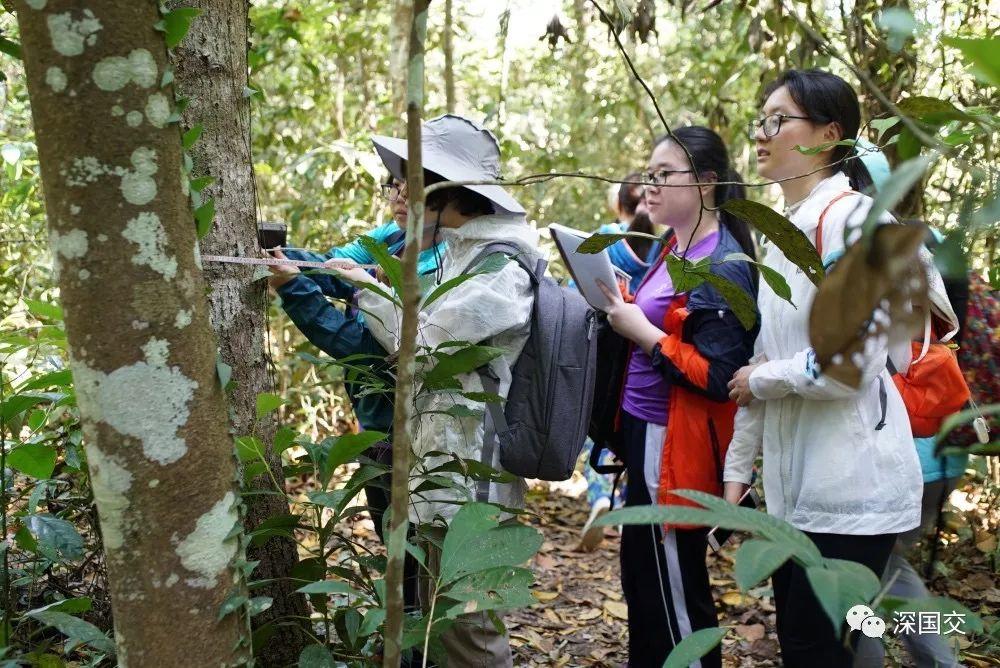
[592,126,756,668]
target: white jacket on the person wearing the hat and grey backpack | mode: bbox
[359,214,539,522]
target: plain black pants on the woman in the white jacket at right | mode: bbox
[771,532,896,668]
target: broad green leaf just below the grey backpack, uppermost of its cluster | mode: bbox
[440,503,542,584]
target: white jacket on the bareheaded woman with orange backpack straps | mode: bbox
[723,173,956,535]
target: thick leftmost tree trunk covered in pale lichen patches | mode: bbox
[14,0,249,666]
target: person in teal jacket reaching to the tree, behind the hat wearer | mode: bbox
[269,178,444,539]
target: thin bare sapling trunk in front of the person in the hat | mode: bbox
[382,0,430,668]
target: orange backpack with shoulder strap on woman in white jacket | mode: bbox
[816,190,971,438]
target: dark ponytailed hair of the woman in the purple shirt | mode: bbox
[655,125,756,260]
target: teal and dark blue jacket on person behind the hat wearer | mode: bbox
[278,222,444,433]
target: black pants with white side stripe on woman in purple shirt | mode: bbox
[621,413,722,668]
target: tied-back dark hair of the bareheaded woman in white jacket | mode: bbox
[763,69,875,194]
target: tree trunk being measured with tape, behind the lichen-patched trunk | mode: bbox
[170,0,309,666]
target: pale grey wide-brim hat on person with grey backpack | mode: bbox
[372,114,524,213]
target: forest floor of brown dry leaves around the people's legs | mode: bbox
[340,476,1000,668]
